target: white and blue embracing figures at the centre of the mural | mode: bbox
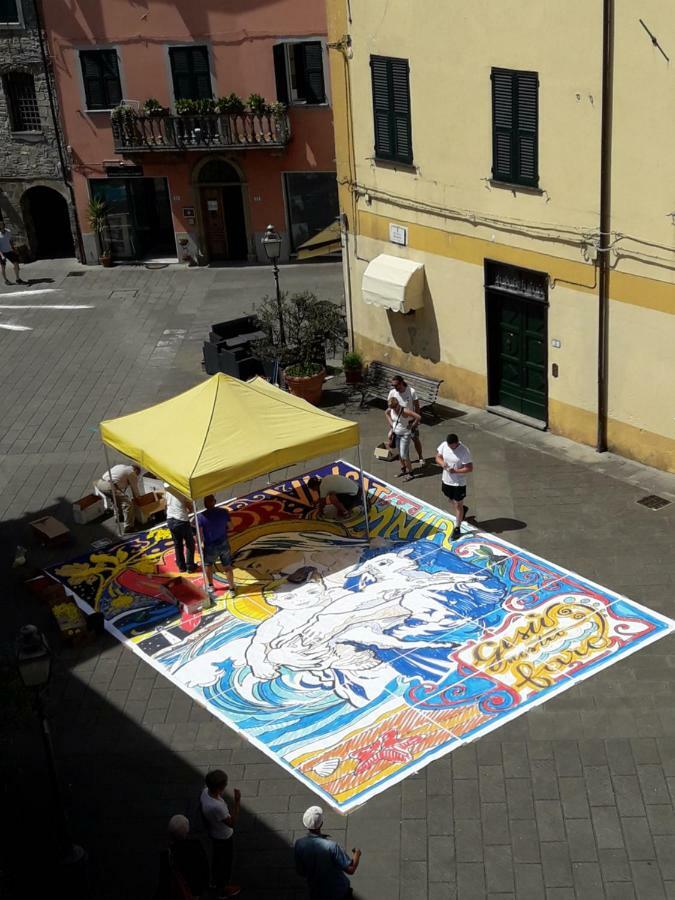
[162,535,503,707]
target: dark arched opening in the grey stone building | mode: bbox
[21,185,75,259]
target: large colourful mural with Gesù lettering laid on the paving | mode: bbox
[49,462,675,812]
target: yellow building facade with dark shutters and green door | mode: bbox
[327,0,675,472]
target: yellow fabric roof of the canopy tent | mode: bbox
[101,375,359,500]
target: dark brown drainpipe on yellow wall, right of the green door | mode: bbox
[595,0,614,453]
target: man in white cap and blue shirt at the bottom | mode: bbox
[295,806,361,900]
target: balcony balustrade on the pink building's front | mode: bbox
[112,111,291,154]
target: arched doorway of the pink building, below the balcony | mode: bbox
[194,158,249,262]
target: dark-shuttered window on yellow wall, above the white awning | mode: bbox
[370,56,413,165]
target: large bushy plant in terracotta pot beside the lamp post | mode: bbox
[255,291,347,405]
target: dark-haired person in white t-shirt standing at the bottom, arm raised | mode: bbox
[199,769,241,900]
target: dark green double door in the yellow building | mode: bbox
[486,267,548,423]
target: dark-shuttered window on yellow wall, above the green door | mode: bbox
[491,69,539,187]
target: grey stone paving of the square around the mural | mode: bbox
[0,263,675,900]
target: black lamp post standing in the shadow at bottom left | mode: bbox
[16,625,87,896]
